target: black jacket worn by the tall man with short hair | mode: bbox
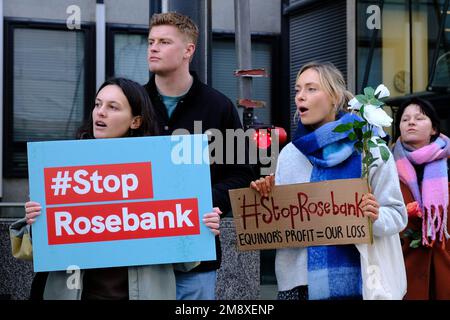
[144,72,255,272]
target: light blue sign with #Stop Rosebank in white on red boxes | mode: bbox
[28,135,216,271]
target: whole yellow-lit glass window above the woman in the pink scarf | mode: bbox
[356,0,450,97]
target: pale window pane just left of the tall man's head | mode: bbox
[114,33,149,84]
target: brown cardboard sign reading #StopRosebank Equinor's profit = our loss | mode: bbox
[229,179,372,250]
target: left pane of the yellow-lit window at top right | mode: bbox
[356,0,410,96]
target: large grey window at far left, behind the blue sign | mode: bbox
[5,26,86,176]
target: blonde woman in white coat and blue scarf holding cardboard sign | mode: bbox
[250,62,407,300]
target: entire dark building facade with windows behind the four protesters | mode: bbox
[0,0,450,299]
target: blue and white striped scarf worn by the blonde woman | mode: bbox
[292,113,362,300]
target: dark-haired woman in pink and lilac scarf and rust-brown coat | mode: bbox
[393,98,450,300]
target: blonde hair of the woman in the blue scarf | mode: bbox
[294,61,353,119]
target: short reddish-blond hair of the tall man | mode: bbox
[150,12,198,45]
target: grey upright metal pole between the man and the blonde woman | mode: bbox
[234,0,253,129]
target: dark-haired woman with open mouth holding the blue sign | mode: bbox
[10,78,221,300]
